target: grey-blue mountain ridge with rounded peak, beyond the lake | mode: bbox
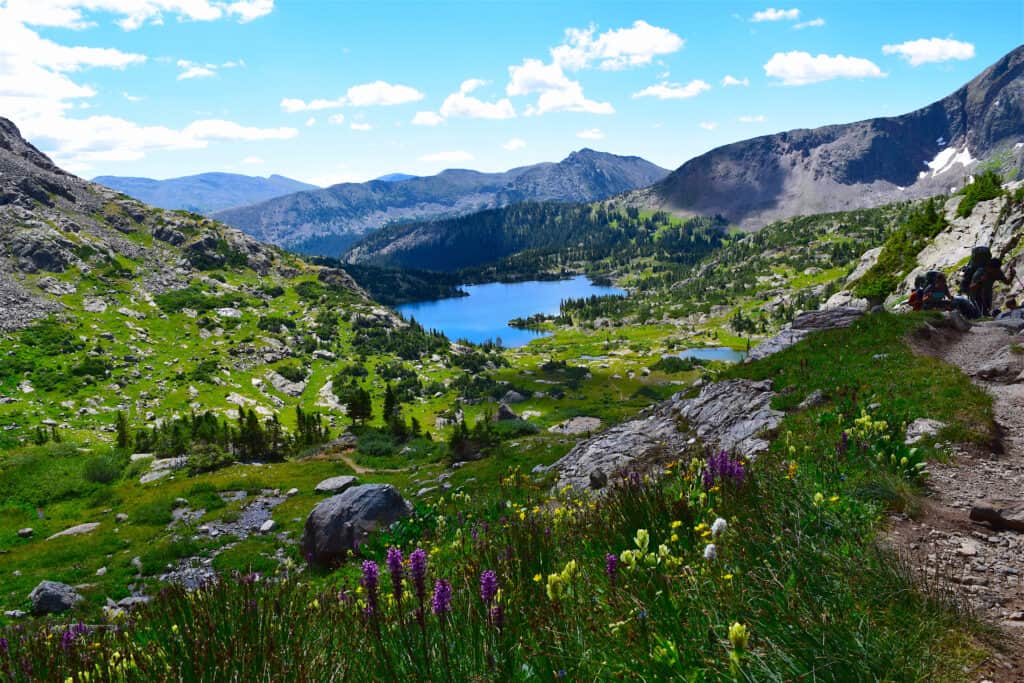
[216,150,669,256]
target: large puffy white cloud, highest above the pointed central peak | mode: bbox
[551,20,685,71]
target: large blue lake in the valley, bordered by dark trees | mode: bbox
[397,275,626,346]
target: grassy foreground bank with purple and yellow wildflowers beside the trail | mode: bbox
[0,315,991,682]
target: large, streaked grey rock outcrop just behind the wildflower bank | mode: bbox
[551,380,783,490]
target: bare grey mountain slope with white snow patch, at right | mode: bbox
[629,47,1024,228]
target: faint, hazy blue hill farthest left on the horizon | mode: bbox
[92,173,317,213]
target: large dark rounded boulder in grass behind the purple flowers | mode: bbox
[301,483,412,565]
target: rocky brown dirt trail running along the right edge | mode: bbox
[890,325,1024,683]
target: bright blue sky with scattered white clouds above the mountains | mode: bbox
[0,0,1024,184]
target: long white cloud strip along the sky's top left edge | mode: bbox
[4,0,273,31]
